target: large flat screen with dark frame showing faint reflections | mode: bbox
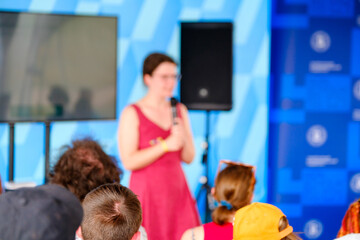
[0,12,117,122]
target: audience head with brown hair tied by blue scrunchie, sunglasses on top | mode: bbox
[212,160,256,225]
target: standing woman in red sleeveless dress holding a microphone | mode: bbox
[118,53,200,240]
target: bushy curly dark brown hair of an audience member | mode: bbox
[50,138,122,202]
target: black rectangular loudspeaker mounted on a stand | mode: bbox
[180,22,233,110]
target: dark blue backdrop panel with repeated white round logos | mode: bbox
[269,0,360,239]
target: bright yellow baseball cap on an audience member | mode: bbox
[233,202,293,240]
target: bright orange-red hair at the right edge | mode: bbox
[337,199,360,237]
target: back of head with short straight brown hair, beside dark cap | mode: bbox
[81,183,142,240]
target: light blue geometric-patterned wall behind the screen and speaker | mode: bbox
[0,0,270,221]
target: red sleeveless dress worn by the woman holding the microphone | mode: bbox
[130,104,200,240]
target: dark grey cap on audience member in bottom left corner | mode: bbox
[0,184,83,240]
